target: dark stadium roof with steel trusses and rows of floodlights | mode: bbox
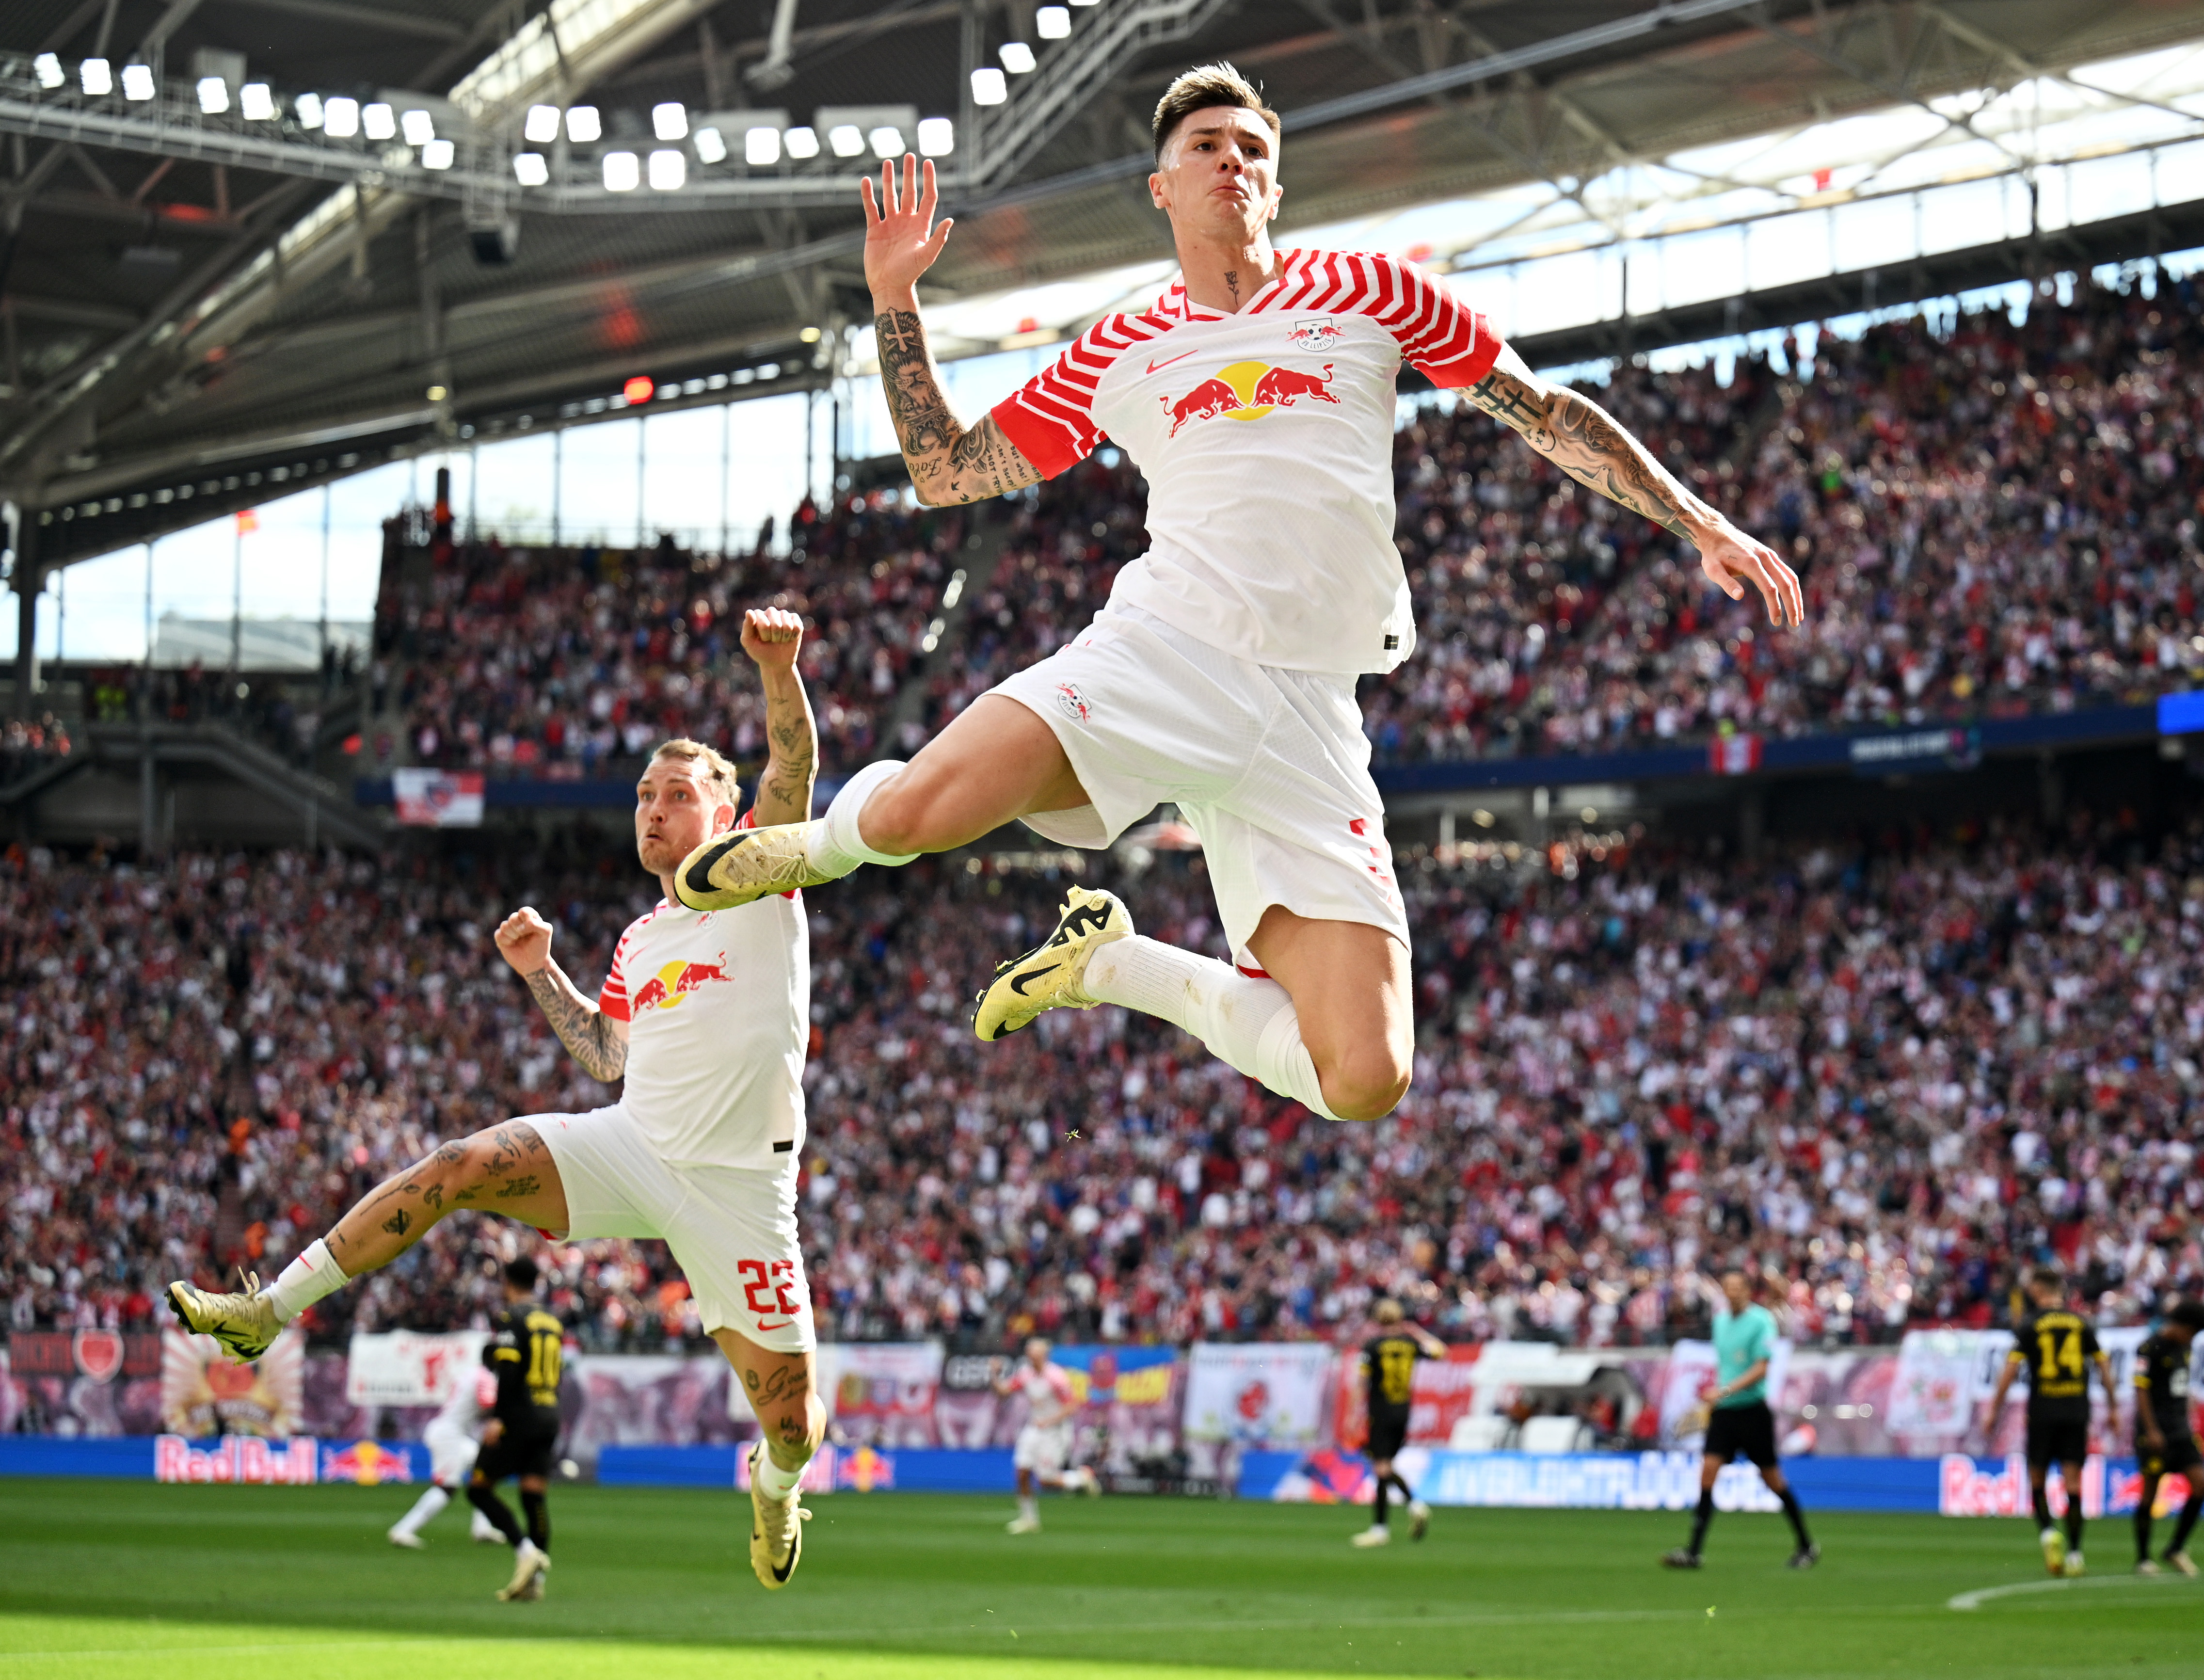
[0,0,2204,562]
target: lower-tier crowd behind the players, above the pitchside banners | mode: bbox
[0,798,2204,1349]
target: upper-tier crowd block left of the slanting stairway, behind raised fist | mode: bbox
[370,492,965,778]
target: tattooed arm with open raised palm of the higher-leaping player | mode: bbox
[864,154,1040,507]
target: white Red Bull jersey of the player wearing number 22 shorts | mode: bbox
[597,811,811,1166]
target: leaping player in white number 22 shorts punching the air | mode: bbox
[167,611,827,1596]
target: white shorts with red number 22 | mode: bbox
[525,1103,818,1354]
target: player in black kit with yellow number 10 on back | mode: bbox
[467,1254,566,1603]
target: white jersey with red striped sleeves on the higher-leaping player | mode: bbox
[994,251,1501,674]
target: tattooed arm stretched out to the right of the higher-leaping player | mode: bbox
[1466,348,1805,624]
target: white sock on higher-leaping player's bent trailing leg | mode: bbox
[1080,932,1340,1120]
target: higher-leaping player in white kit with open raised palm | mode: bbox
[674,64,1803,1120]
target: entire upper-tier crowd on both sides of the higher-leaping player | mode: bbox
[352,278,2204,776]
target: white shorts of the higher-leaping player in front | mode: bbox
[992,606,1408,970]
